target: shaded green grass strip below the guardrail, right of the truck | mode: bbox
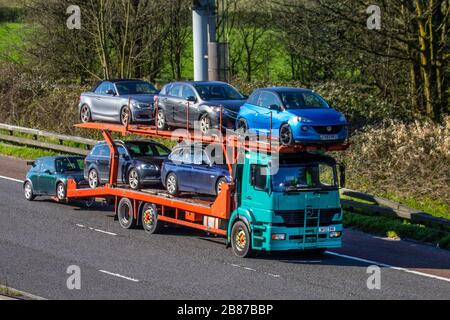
[344,212,450,249]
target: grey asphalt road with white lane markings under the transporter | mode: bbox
[0,158,450,300]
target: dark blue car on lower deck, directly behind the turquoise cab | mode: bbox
[161,145,231,196]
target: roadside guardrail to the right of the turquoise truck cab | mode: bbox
[341,189,450,227]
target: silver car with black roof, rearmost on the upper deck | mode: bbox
[78,79,159,125]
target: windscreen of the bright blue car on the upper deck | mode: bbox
[280,91,330,109]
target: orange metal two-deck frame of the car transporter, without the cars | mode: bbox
[67,123,350,236]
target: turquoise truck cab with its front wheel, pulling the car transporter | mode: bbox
[228,151,345,257]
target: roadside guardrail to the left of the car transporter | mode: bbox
[0,123,98,155]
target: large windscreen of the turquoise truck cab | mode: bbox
[272,163,338,192]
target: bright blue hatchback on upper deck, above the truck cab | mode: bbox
[236,87,348,145]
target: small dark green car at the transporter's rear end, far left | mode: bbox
[23,156,86,201]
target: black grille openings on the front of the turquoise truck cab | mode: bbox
[273,209,341,228]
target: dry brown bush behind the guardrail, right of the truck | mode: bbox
[337,117,450,213]
